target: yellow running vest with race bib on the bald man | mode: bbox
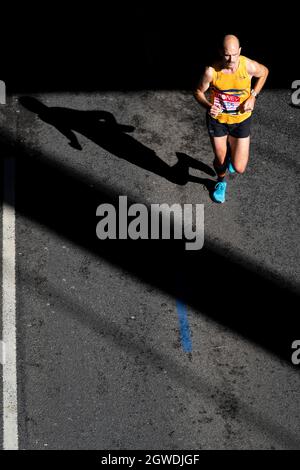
[209,56,252,124]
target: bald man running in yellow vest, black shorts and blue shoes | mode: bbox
[195,34,269,203]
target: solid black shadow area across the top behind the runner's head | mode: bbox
[0,2,299,94]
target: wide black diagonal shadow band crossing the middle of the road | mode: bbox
[1,123,299,366]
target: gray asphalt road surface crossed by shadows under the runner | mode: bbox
[0,90,300,450]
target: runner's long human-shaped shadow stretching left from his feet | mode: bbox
[19,96,215,189]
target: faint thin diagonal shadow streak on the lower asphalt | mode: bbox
[20,270,300,449]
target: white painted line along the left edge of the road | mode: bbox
[2,158,18,450]
